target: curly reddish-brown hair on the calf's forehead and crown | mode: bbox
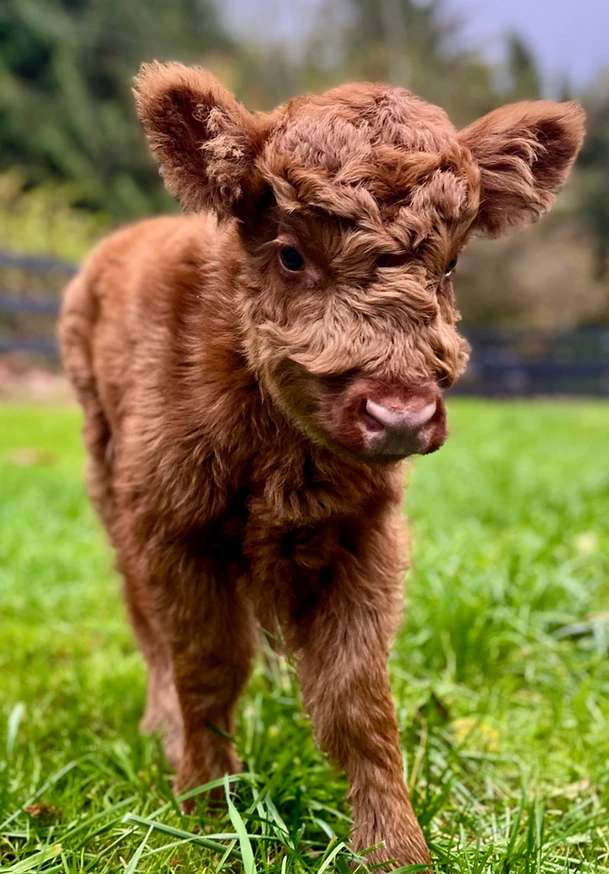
[259,83,480,253]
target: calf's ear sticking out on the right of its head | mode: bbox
[459,100,585,237]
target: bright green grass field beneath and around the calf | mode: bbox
[0,401,609,874]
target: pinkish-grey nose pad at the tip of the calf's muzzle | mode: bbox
[362,399,438,458]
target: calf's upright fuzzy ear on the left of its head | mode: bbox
[133,62,268,215]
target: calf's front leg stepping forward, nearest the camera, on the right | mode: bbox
[286,518,430,866]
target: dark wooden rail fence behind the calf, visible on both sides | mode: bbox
[0,245,609,397]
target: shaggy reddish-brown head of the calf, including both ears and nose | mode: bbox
[135,64,583,462]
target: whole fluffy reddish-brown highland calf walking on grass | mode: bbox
[61,64,583,865]
